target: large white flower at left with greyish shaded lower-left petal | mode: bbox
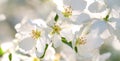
[15,19,49,57]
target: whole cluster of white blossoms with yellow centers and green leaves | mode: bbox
[0,0,120,61]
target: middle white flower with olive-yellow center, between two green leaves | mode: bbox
[48,15,74,47]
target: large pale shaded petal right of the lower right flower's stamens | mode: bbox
[78,30,103,56]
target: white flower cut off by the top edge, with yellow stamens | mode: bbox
[53,0,87,20]
